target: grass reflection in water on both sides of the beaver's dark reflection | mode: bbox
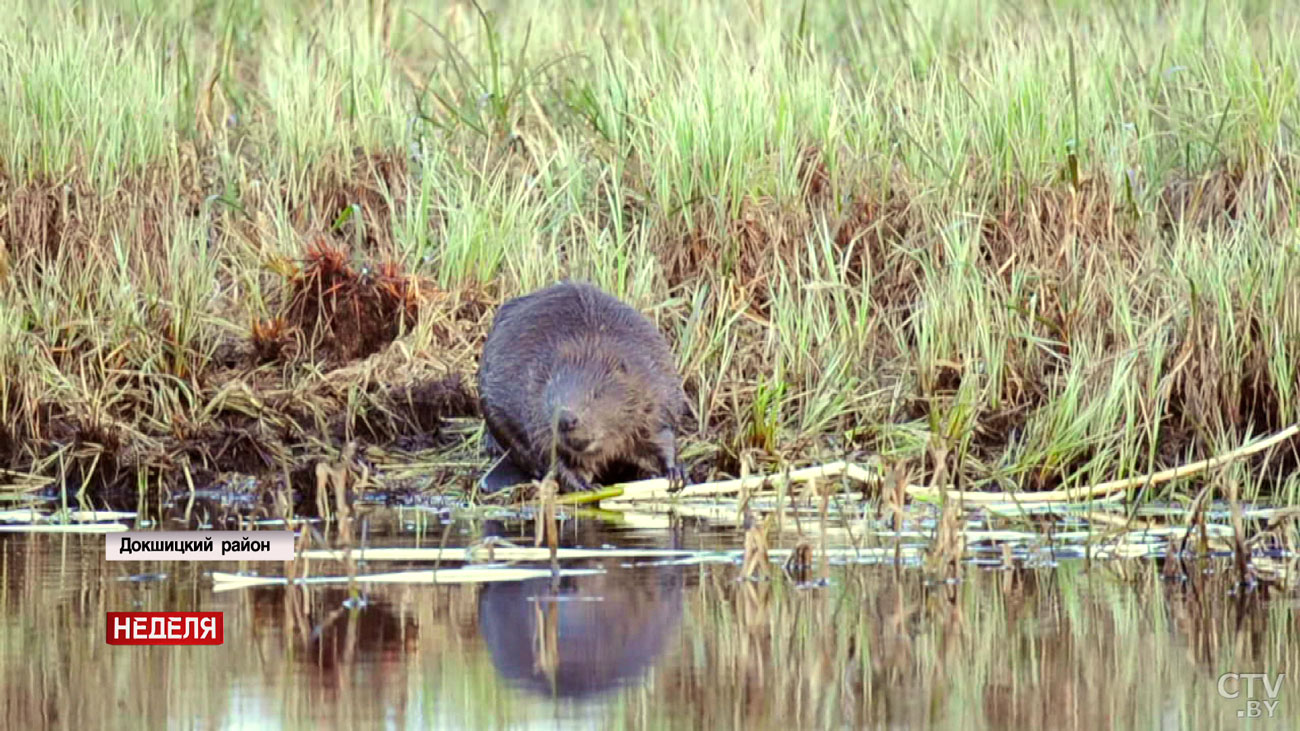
[0,528,1300,728]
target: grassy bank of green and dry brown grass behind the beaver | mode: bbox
[0,0,1300,502]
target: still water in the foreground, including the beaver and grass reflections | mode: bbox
[0,504,1300,730]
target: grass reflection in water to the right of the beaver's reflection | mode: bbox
[628,563,1296,728]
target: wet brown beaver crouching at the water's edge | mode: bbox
[478,281,686,492]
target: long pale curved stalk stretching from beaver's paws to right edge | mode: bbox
[603,424,1300,505]
